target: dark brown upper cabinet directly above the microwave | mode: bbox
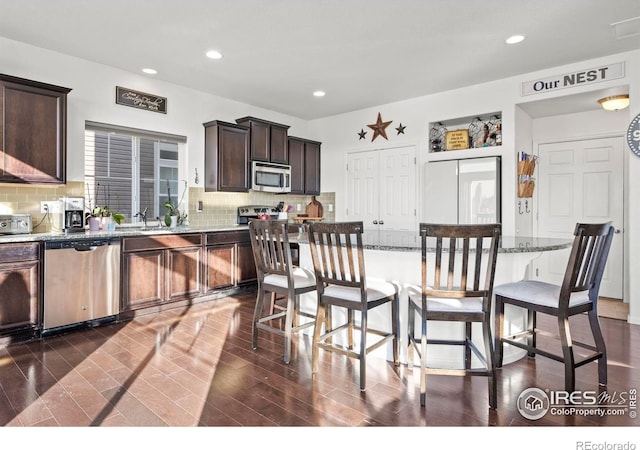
[236,117,289,164]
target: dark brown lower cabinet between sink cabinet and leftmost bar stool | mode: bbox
[204,230,257,294]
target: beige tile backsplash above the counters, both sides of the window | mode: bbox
[0,182,335,233]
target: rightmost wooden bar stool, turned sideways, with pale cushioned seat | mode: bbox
[495,223,614,392]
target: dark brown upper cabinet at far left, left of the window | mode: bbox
[0,74,71,184]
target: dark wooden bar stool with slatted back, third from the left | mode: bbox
[408,223,501,409]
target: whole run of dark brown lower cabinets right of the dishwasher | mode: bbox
[120,230,257,315]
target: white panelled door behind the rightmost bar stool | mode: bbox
[536,137,624,298]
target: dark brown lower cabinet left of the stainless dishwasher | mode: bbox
[0,242,42,338]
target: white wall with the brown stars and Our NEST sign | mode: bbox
[309,51,640,323]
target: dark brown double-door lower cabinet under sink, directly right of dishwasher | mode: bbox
[121,233,202,311]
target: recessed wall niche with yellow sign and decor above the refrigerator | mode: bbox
[429,112,502,155]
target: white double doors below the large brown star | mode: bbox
[347,147,417,236]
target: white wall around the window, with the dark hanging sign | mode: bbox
[0,37,308,186]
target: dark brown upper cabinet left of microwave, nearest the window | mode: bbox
[203,120,251,192]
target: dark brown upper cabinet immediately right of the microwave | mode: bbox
[288,136,321,195]
